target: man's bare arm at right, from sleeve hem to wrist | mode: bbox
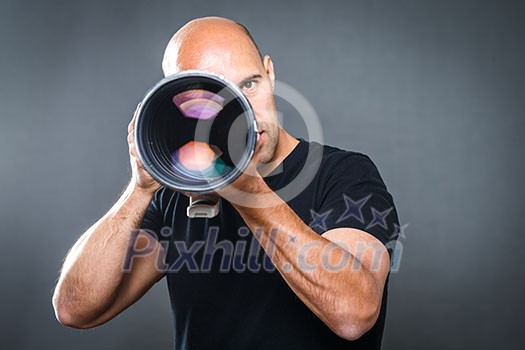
[224,176,390,340]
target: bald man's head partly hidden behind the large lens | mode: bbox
[162,17,298,167]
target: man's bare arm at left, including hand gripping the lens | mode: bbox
[53,108,164,328]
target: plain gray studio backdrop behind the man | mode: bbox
[0,0,525,350]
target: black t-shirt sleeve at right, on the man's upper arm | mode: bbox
[310,153,399,251]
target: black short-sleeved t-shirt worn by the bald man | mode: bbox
[142,140,398,349]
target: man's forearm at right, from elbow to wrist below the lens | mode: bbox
[234,178,383,339]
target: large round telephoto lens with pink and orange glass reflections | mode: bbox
[135,71,257,194]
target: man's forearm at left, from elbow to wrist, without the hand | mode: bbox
[53,184,154,323]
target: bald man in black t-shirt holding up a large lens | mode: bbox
[53,18,397,349]
